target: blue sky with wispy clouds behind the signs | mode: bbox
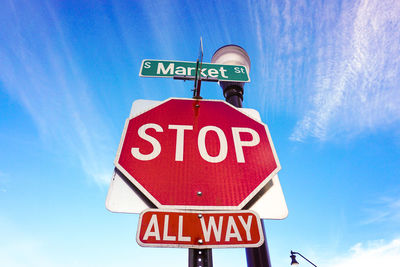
[0,0,400,267]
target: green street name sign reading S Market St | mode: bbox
[139,59,250,82]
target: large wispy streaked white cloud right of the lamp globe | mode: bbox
[247,0,400,141]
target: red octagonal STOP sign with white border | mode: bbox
[115,98,280,210]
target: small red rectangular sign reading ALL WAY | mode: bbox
[136,209,264,249]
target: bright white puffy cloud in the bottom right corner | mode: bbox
[323,238,400,267]
